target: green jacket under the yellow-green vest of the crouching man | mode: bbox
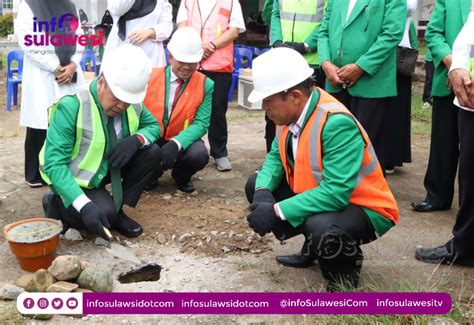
[44,81,161,207]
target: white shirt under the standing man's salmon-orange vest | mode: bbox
[176,0,245,33]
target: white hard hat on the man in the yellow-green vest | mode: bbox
[102,44,152,104]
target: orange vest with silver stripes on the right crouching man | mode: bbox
[277,88,399,223]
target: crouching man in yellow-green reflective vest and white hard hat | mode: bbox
[40,45,161,239]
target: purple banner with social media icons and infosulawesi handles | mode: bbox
[17,292,452,314]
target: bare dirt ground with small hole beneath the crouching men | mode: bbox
[0,82,474,324]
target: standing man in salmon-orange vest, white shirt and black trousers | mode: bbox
[176,0,245,172]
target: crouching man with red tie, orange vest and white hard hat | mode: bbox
[144,27,214,193]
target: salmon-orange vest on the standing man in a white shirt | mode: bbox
[185,0,234,72]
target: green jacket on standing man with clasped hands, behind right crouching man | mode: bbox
[318,0,407,98]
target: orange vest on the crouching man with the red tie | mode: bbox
[143,67,206,140]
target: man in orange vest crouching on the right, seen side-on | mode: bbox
[245,48,399,291]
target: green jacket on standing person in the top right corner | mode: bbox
[425,0,471,96]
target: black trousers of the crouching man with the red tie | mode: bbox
[158,140,209,184]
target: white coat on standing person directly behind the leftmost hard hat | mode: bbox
[102,0,173,67]
